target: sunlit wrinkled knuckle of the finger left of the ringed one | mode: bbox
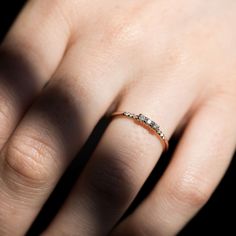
[4,133,57,184]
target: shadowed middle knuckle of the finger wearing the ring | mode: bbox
[87,154,135,209]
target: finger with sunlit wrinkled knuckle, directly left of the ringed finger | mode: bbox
[0,34,130,235]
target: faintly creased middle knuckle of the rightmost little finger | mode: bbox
[169,174,210,207]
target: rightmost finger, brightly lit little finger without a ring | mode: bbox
[112,94,236,235]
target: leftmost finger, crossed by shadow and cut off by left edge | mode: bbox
[0,0,70,149]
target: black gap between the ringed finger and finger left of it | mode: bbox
[27,110,109,235]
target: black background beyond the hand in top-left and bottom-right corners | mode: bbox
[0,0,236,236]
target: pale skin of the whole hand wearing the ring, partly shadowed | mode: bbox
[0,0,236,236]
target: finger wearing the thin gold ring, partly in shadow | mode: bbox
[45,74,200,236]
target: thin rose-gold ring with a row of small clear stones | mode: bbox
[111,111,169,151]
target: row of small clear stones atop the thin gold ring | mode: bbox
[123,112,165,140]
